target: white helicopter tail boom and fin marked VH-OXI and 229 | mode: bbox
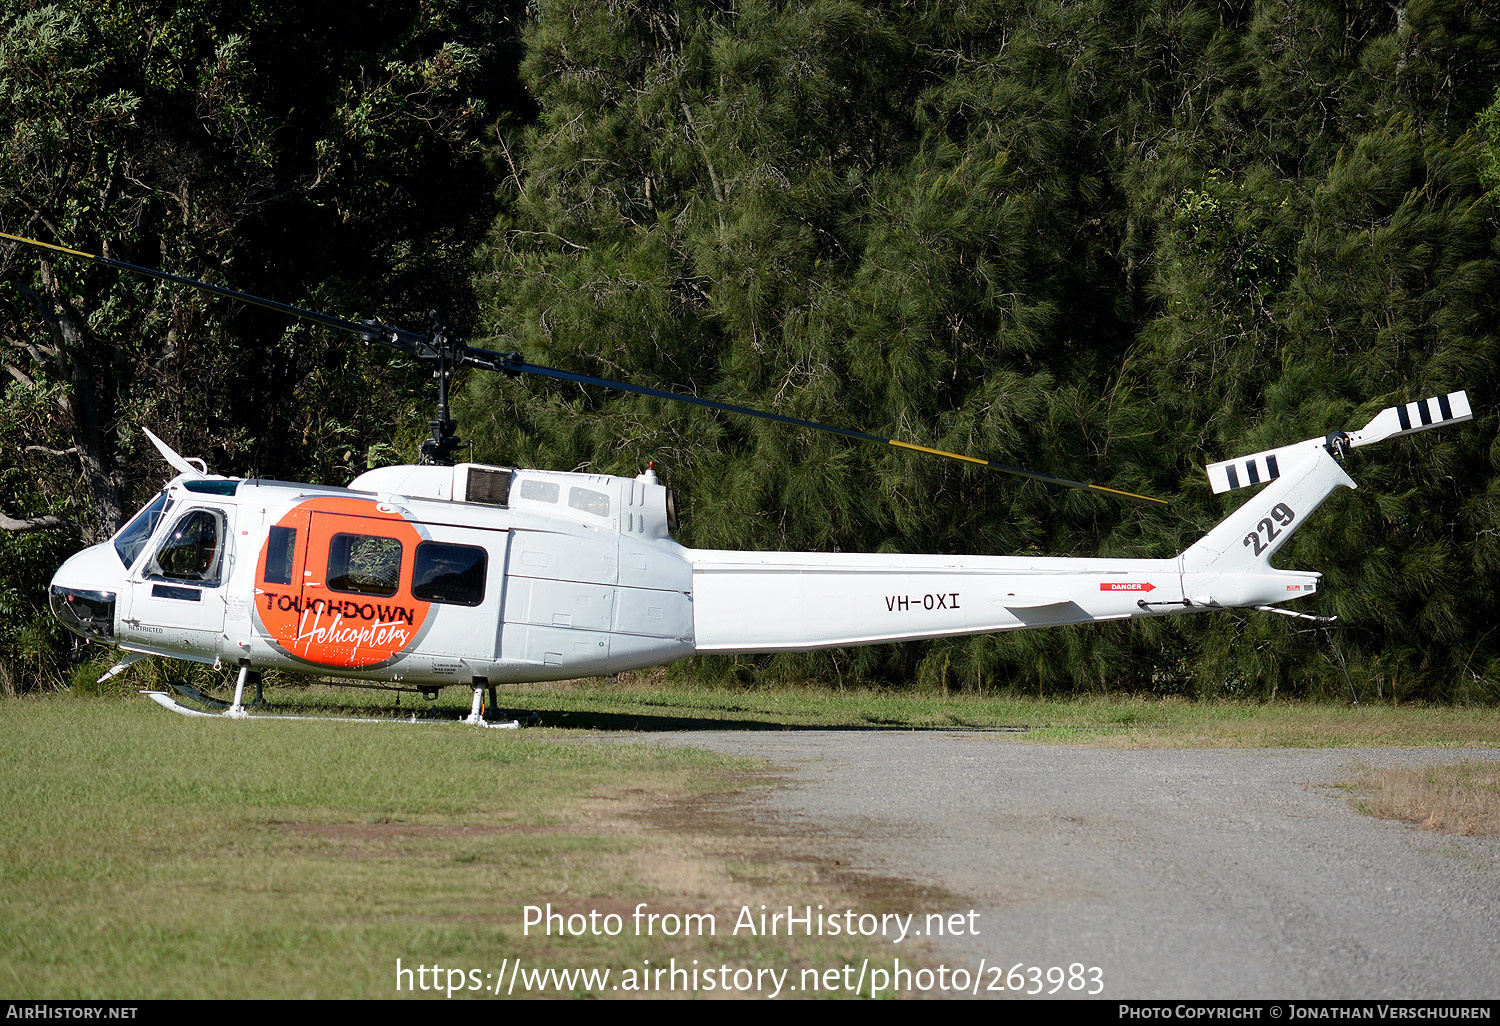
[684,441,1374,654]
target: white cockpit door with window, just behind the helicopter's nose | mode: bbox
[120,506,236,662]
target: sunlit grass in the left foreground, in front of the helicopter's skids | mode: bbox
[0,695,912,998]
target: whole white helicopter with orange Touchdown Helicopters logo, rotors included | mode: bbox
[0,233,1473,723]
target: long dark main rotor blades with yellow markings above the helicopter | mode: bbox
[0,231,1167,506]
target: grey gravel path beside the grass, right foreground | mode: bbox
[636,731,1500,999]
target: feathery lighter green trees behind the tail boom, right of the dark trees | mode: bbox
[467,0,1497,699]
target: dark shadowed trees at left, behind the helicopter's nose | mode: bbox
[0,0,525,690]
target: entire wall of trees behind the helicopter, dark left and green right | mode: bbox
[0,0,1500,702]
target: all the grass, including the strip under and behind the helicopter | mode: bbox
[0,681,1500,998]
